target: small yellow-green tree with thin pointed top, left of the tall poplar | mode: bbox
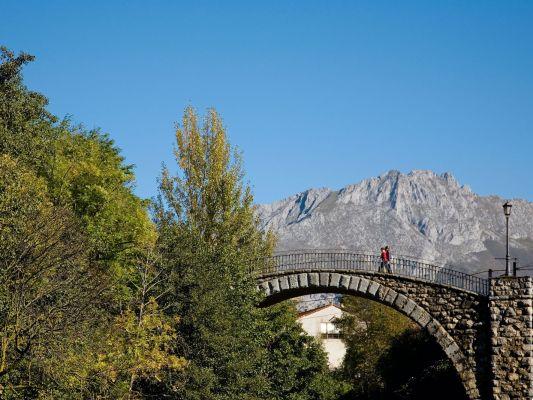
[52,252,186,400]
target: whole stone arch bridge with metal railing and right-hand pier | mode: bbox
[257,250,533,400]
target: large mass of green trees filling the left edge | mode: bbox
[0,47,163,399]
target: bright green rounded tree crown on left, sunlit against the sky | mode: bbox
[49,128,155,307]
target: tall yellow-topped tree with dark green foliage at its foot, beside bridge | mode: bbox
[154,108,340,400]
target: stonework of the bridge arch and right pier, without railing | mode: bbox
[258,269,533,400]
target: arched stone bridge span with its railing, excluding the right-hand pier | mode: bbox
[257,251,489,399]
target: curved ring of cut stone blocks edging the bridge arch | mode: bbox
[258,272,480,399]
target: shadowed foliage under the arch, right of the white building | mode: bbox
[339,296,465,400]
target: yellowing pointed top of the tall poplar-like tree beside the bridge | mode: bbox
[166,107,273,264]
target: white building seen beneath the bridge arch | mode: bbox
[298,304,346,369]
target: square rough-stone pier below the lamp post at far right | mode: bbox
[489,277,533,400]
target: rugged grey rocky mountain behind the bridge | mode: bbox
[257,170,533,272]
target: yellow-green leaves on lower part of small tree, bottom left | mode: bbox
[56,298,186,399]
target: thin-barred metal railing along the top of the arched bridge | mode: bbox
[256,251,489,295]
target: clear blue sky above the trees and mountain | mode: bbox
[0,0,533,202]
